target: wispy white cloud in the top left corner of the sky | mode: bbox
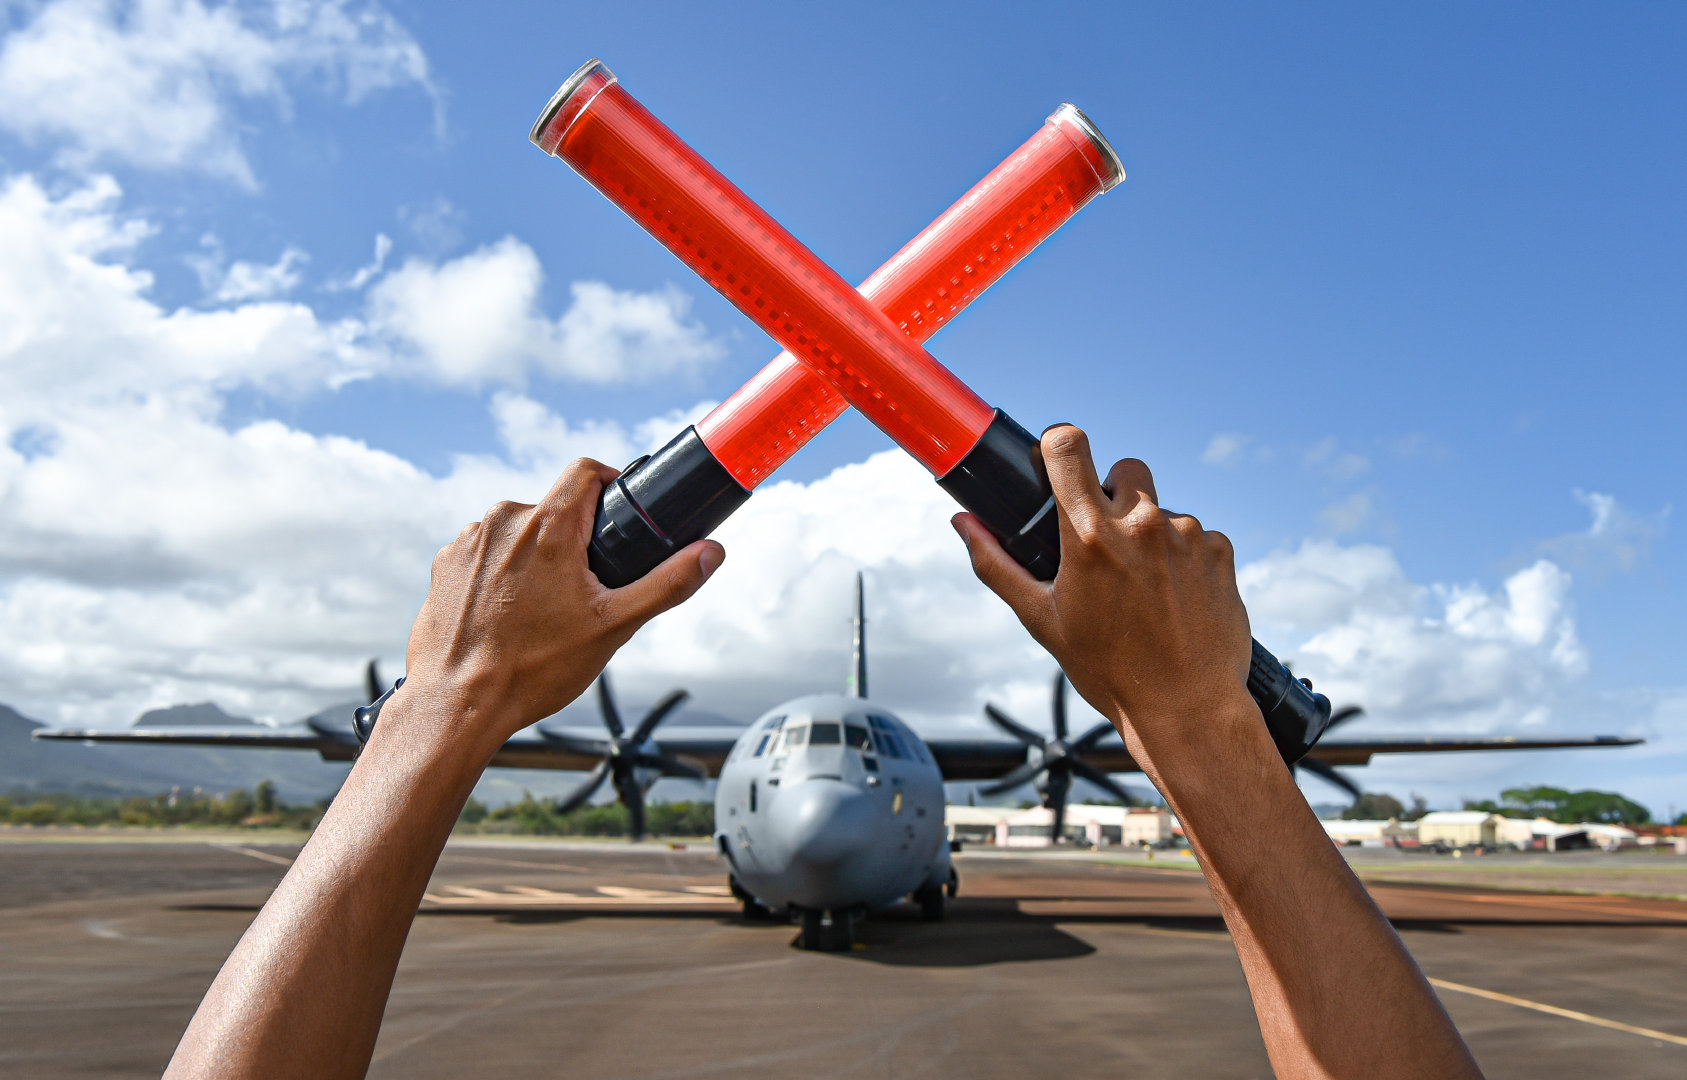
[0,0,439,187]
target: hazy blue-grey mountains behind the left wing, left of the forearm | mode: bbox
[0,705,346,803]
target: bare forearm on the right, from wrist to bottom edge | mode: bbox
[1156,700,1479,1080]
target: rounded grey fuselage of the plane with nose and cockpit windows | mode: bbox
[715,694,950,911]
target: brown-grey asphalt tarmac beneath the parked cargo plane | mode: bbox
[0,839,1687,1080]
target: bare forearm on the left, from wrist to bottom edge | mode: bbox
[165,687,489,1078]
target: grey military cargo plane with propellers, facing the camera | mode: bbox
[35,574,1640,950]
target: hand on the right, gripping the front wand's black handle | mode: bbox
[955,425,1264,771]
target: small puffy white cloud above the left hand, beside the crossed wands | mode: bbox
[369,236,722,386]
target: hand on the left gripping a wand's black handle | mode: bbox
[386,457,725,758]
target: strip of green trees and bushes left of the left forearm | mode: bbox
[0,780,327,830]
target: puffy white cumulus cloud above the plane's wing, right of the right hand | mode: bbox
[1238,540,1587,732]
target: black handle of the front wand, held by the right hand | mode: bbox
[938,410,1329,764]
